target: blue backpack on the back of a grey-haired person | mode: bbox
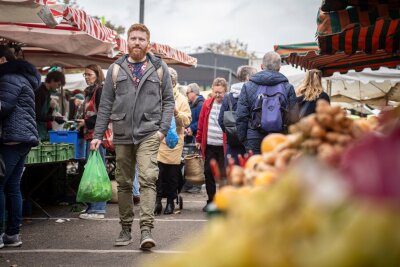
[250,83,289,133]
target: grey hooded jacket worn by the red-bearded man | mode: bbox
[94,54,175,144]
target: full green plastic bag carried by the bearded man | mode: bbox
[76,151,112,202]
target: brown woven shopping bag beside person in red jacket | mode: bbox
[184,153,205,185]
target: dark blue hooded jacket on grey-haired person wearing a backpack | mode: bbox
[236,70,298,143]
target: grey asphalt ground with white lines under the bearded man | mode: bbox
[0,191,207,266]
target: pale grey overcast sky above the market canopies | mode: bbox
[77,0,321,55]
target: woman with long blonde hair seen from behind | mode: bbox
[296,69,330,119]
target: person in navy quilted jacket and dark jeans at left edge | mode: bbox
[0,45,40,248]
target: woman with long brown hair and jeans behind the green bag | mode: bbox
[76,64,107,220]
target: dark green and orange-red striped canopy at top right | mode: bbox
[276,0,400,77]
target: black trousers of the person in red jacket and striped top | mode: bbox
[204,145,225,202]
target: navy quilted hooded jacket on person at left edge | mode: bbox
[0,60,40,145]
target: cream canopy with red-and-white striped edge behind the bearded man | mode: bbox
[0,0,197,66]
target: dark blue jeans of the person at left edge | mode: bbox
[0,144,31,235]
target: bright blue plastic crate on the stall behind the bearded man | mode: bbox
[49,131,86,159]
